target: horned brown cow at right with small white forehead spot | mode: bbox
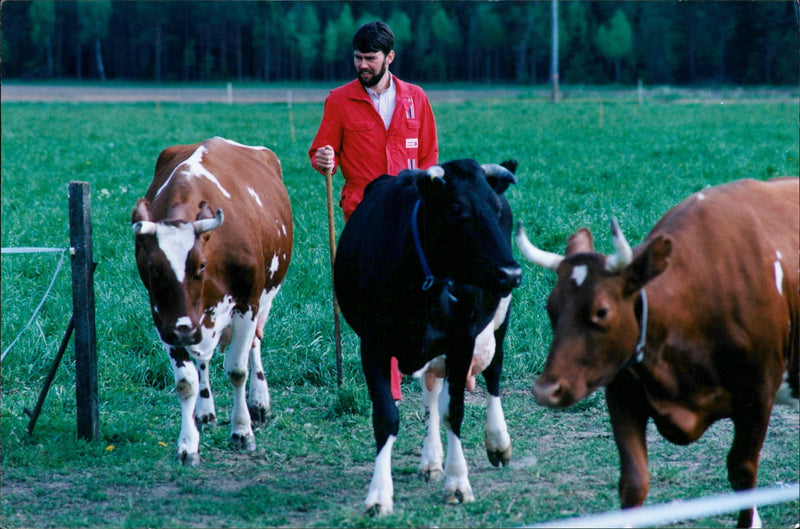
[517,178,800,526]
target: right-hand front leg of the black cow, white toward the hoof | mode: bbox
[439,365,475,504]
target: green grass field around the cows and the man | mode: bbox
[0,85,800,527]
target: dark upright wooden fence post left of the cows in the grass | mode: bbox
[69,182,100,441]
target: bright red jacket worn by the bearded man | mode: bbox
[308,76,439,220]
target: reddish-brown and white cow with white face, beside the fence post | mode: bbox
[131,138,293,465]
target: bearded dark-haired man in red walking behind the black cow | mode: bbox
[308,21,439,400]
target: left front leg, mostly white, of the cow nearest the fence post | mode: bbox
[166,346,200,466]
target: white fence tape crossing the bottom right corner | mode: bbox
[523,483,800,528]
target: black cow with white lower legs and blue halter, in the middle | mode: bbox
[334,160,521,514]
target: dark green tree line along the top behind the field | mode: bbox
[2,0,800,84]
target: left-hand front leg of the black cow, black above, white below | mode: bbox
[361,340,400,515]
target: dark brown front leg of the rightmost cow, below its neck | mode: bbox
[606,372,650,509]
